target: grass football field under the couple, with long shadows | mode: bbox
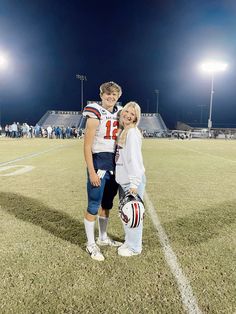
[0,138,236,314]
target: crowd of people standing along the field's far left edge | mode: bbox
[0,122,83,139]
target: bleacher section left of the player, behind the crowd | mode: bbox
[38,110,82,128]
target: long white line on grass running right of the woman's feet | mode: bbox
[144,192,202,314]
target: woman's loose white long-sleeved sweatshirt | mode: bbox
[116,128,145,188]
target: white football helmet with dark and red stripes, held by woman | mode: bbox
[119,193,145,228]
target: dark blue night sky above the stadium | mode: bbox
[0,0,236,128]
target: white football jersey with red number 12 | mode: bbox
[83,103,121,154]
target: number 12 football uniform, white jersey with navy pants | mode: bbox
[83,103,122,215]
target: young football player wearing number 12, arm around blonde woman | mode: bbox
[83,82,122,261]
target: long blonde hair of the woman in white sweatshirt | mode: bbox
[117,101,141,146]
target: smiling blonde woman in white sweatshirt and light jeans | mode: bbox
[116,101,146,256]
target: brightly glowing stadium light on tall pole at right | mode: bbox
[200,61,228,137]
